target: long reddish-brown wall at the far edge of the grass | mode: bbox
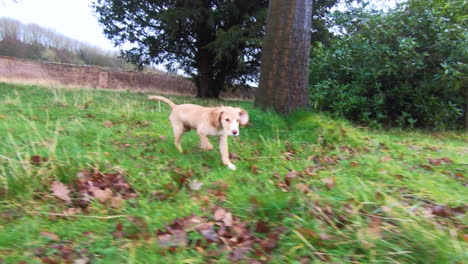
[0,56,196,95]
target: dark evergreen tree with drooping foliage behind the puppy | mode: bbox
[93,0,268,97]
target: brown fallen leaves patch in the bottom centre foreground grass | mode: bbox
[109,206,286,261]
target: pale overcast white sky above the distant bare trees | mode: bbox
[0,0,117,50]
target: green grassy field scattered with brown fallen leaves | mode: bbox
[0,83,468,263]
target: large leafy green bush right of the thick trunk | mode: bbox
[310,0,468,128]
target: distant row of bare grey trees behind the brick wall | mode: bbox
[0,18,135,70]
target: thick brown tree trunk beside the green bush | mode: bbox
[255,0,312,114]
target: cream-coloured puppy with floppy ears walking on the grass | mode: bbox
[148,95,249,170]
